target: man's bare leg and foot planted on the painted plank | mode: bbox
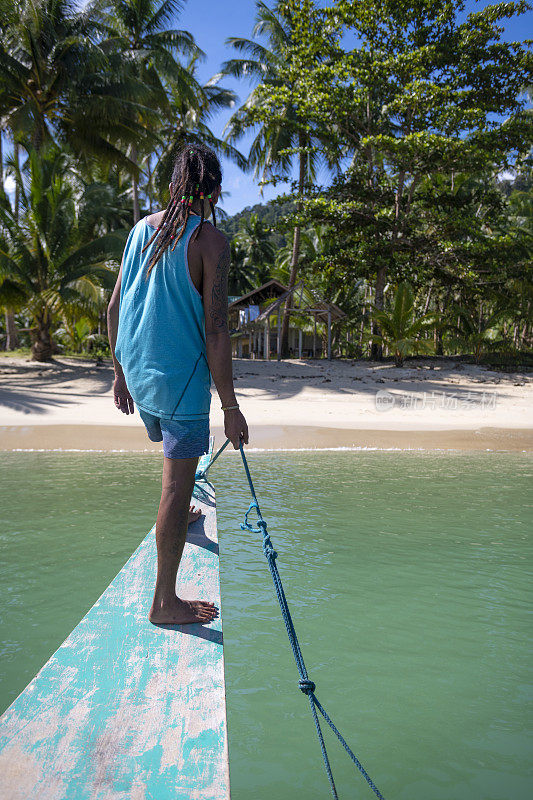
[149,457,218,625]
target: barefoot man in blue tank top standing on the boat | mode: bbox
[107,144,248,624]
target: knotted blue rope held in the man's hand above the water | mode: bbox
[196,439,385,800]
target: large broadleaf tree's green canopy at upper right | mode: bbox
[247,0,533,356]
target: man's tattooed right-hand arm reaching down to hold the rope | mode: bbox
[201,226,248,450]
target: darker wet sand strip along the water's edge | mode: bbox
[0,424,533,454]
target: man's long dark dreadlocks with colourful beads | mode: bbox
[142,144,222,277]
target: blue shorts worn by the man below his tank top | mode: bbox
[137,407,209,458]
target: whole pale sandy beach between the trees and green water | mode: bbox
[0,355,533,452]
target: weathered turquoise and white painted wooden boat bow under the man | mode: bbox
[0,450,230,800]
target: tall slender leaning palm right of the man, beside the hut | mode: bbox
[217,0,331,356]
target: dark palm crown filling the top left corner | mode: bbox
[0,0,148,169]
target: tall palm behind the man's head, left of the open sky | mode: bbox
[102,0,204,222]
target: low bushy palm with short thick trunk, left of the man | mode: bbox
[0,144,125,361]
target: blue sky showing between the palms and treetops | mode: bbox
[6,0,533,215]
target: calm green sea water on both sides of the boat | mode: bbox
[0,452,533,800]
